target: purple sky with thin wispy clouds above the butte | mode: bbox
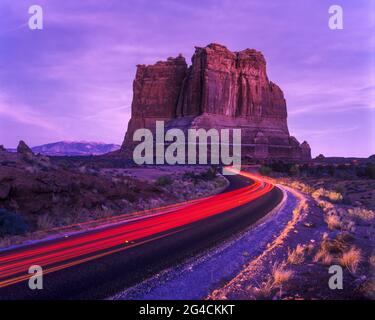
[0,0,375,157]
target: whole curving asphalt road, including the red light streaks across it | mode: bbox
[0,172,282,299]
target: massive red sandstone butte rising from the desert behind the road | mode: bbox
[122,43,311,161]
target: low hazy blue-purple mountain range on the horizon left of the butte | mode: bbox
[9,141,120,156]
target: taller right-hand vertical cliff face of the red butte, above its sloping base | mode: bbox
[177,44,286,119]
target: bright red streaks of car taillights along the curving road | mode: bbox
[0,172,274,288]
